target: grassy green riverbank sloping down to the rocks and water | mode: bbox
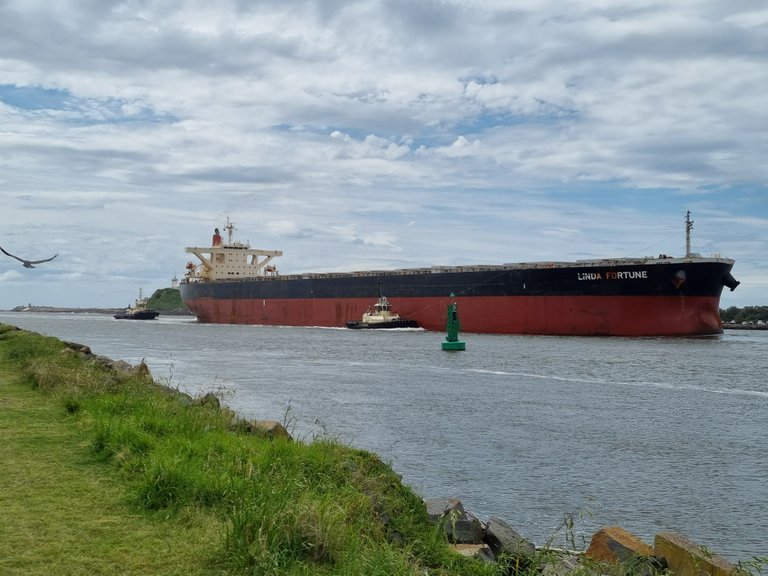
[0,325,492,576]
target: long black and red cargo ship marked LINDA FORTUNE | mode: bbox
[179,212,739,336]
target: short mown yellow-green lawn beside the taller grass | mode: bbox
[0,356,224,575]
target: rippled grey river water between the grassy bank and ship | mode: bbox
[0,312,768,561]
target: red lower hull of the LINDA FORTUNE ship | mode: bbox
[178,296,723,336]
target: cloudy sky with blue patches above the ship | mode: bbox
[0,0,768,309]
